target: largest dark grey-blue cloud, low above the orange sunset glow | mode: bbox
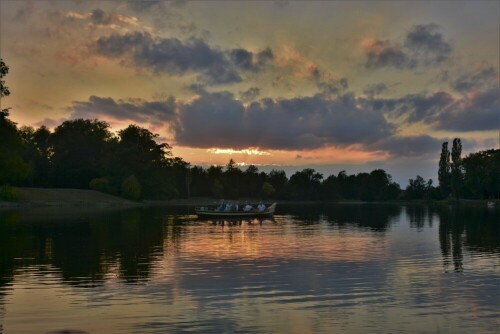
[175,92,393,149]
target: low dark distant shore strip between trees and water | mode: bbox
[0,187,500,209]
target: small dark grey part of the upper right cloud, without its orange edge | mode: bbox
[405,24,452,65]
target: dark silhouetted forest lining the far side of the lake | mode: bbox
[0,60,500,201]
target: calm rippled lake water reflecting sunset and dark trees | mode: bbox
[0,205,500,334]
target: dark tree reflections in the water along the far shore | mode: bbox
[0,204,500,288]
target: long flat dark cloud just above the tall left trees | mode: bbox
[69,96,176,124]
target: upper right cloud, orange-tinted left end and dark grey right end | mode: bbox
[362,24,453,69]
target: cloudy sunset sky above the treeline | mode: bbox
[0,0,500,185]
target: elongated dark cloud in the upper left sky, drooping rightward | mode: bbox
[95,32,273,84]
